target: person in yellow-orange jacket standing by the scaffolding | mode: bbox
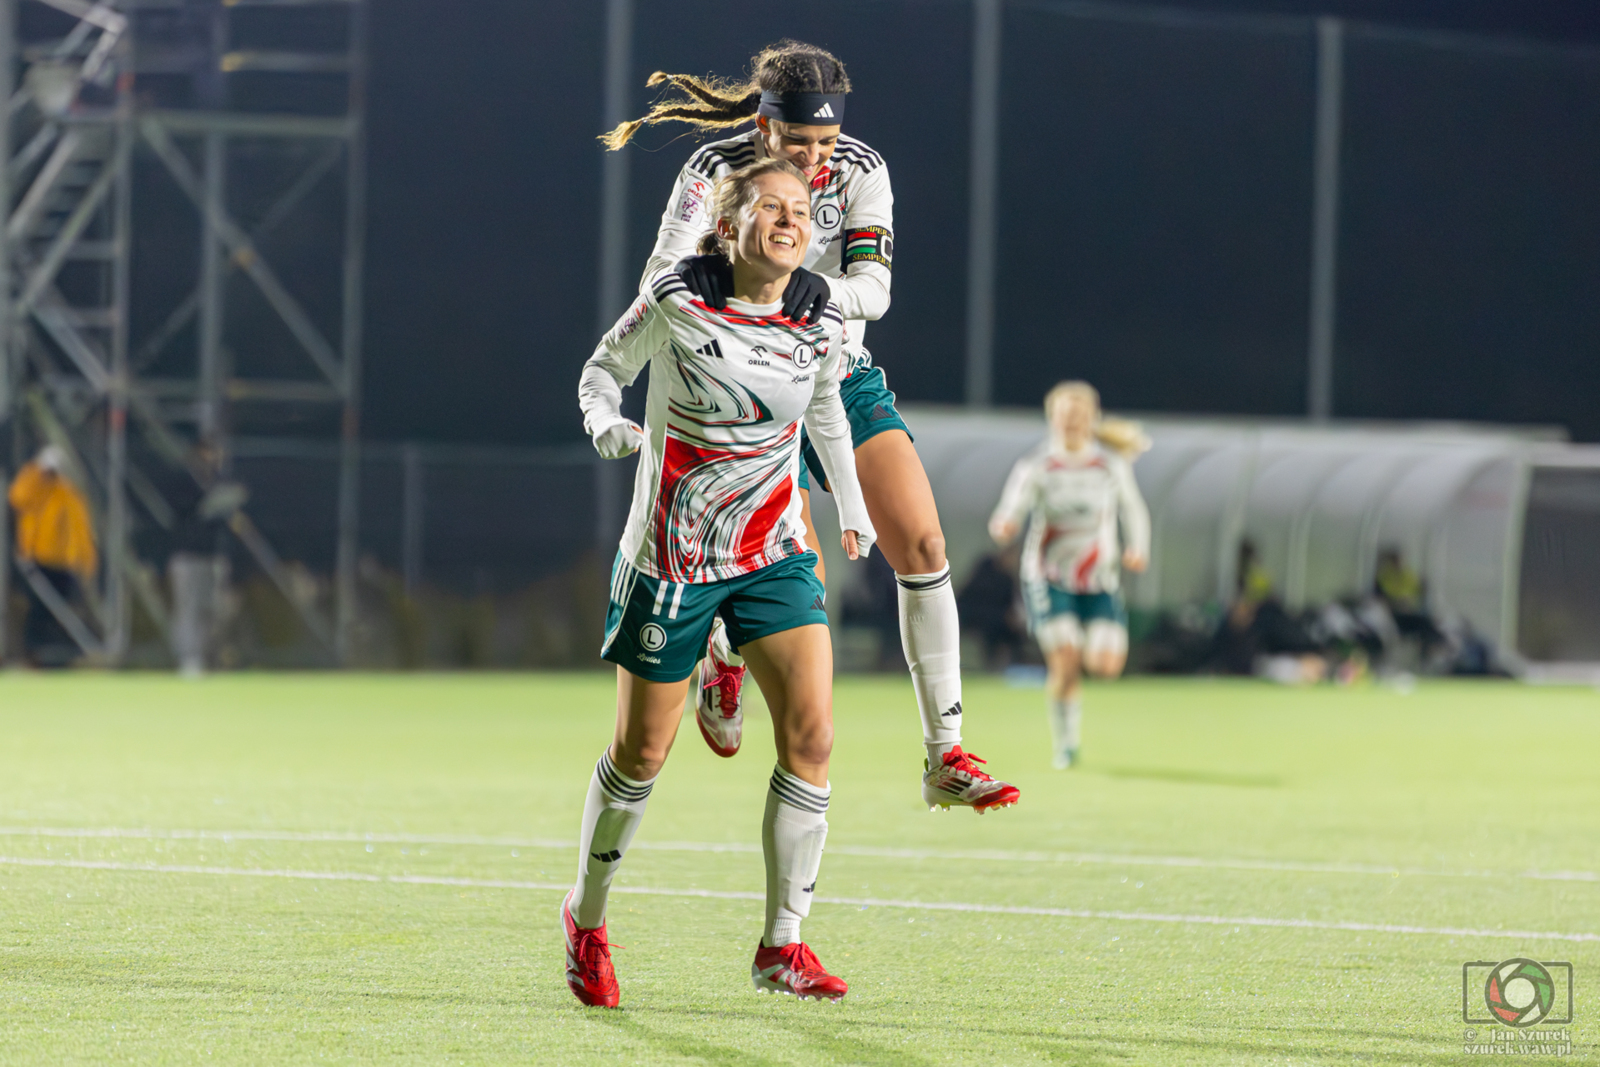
[8,445,99,665]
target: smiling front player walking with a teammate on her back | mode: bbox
[562,160,875,1006]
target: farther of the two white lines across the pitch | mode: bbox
[0,827,1600,883]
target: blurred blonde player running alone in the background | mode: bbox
[989,382,1150,768]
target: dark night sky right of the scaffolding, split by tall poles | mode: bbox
[356,0,1600,445]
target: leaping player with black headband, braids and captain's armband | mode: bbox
[603,42,1019,811]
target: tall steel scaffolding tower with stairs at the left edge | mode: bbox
[0,0,366,664]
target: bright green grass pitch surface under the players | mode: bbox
[0,675,1600,1065]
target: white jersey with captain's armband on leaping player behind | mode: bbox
[640,130,894,376]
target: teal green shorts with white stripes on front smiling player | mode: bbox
[600,552,827,681]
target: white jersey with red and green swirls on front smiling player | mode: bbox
[578,270,875,584]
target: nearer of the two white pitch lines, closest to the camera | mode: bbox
[0,856,1600,942]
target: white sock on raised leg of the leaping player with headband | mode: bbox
[894,563,962,766]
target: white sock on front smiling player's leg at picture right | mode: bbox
[762,766,834,949]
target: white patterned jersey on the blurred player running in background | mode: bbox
[989,443,1150,593]
